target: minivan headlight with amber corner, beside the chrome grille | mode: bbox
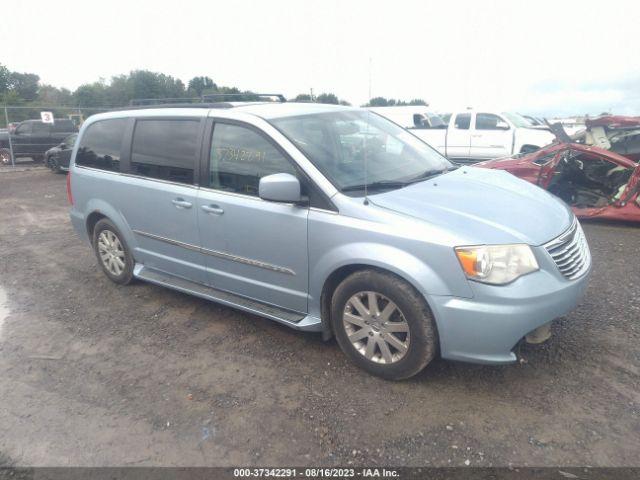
[455,245,539,285]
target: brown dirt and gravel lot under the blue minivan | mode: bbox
[0,170,640,466]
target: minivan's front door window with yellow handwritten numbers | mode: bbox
[209,123,296,196]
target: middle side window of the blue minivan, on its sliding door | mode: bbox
[131,119,200,184]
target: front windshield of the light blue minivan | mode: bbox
[271,110,455,194]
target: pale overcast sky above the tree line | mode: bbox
[0,0,640,114]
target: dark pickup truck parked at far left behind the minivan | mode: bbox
[0,118,78,165]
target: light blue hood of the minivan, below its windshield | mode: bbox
[369,167,573,245]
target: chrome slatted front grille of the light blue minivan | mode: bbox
[544,218,591,280]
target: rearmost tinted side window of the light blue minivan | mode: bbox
[76,118,127,172]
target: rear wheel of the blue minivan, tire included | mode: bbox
[93,218,134,285]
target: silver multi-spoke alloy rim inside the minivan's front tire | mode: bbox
[342,291,410,364]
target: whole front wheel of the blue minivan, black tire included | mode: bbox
[331,270,438,380]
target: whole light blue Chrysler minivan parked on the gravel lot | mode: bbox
[68,102,591,379]
